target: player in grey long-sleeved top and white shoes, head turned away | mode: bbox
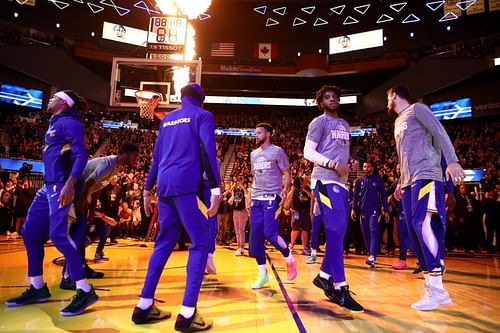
[387,85,464,310]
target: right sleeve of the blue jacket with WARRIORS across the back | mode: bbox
[199,112,221,195]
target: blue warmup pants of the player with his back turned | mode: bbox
[141,194,209,307]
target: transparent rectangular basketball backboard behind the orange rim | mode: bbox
[109,58,201,111]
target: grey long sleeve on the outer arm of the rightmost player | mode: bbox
[415,104,458,164]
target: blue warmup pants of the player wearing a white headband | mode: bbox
[22,183,87,281]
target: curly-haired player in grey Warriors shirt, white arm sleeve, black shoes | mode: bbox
[304,85,363,312]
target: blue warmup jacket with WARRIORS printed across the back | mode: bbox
[144,96,220,198]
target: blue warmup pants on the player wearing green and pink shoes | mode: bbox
[249,196,290,265]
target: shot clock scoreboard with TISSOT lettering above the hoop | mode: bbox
[147,16,188,59]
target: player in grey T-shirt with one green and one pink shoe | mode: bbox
[249,123,297,289]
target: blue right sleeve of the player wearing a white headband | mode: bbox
[62,120,88,178]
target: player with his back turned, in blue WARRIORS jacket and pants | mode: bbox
[132,83,221,332]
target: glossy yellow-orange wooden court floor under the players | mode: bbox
[0,236,500,333]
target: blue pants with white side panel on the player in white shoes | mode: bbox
[402,180,446,271]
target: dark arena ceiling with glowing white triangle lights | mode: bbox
[0,0,500,113]
